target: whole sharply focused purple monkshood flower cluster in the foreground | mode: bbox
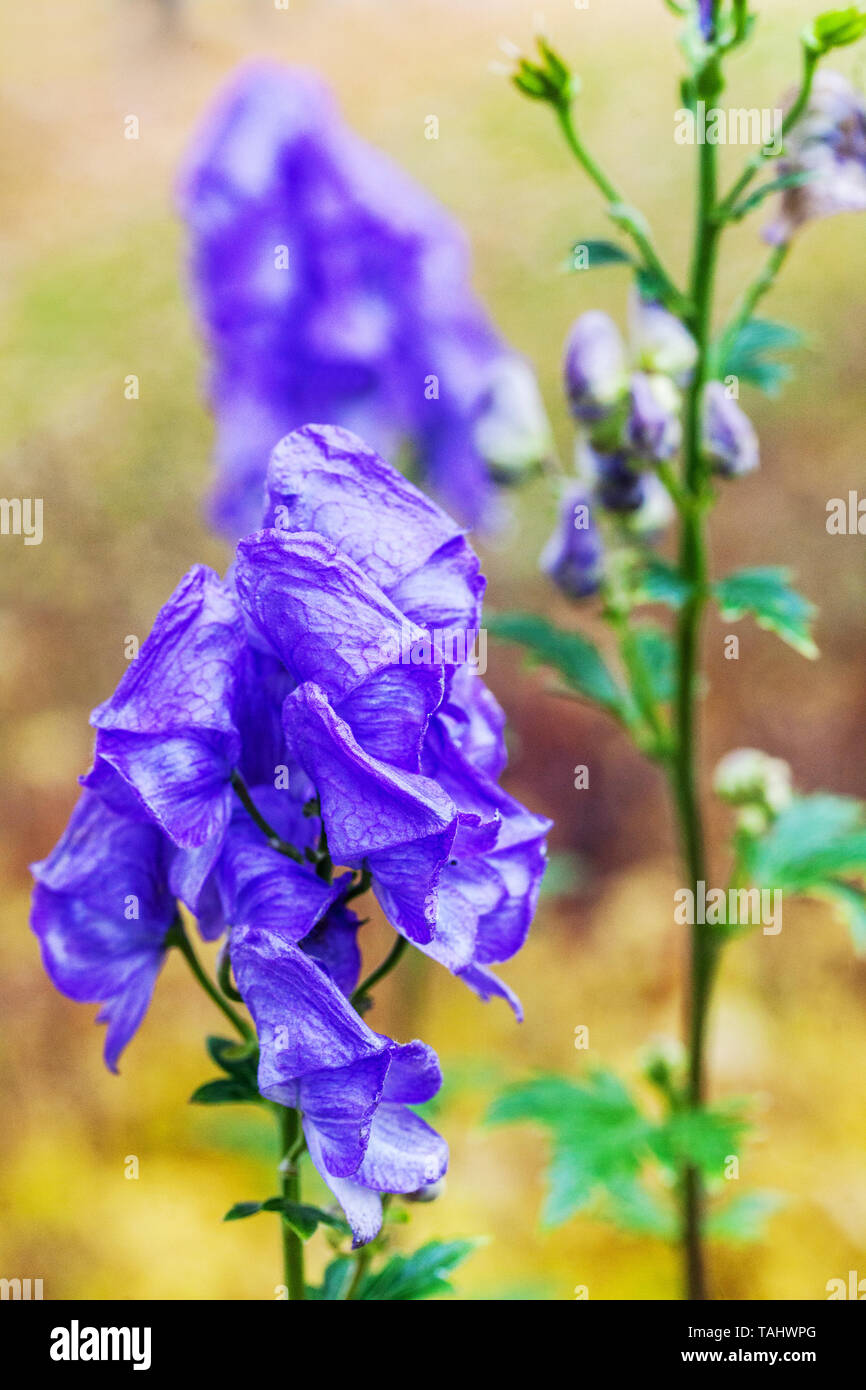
[32,425,550,1243]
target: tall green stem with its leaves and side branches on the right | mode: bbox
[491,0,866,1300]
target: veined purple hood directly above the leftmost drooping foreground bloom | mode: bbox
[92,566,245,847]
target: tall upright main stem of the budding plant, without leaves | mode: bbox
[671,46,721,1300]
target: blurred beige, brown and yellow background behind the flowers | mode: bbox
[0,0,866,1300]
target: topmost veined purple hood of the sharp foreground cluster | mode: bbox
[265,425,485,628]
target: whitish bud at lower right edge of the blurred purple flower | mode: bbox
[474,356,553,482]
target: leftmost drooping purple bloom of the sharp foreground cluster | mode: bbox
[31,791,175,1072]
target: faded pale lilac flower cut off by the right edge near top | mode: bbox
[763,68,866,245]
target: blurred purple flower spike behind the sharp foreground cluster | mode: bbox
[181,63,549,539]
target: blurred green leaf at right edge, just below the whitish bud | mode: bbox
[746,792,866,892]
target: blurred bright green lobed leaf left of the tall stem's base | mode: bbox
[488,1072,652,1226]
